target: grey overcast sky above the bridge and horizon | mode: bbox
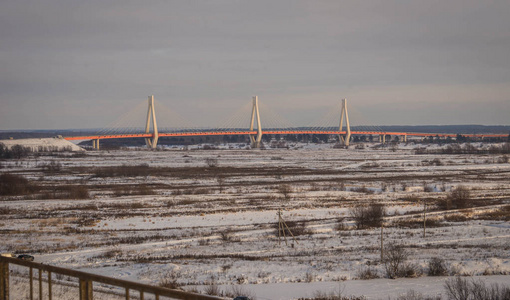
[0,0,510,130]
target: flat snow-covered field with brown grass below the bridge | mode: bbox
[0,143,510,299]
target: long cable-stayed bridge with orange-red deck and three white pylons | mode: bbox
[64,96,508,149]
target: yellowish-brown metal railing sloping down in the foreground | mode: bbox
[0,256,224,300]
